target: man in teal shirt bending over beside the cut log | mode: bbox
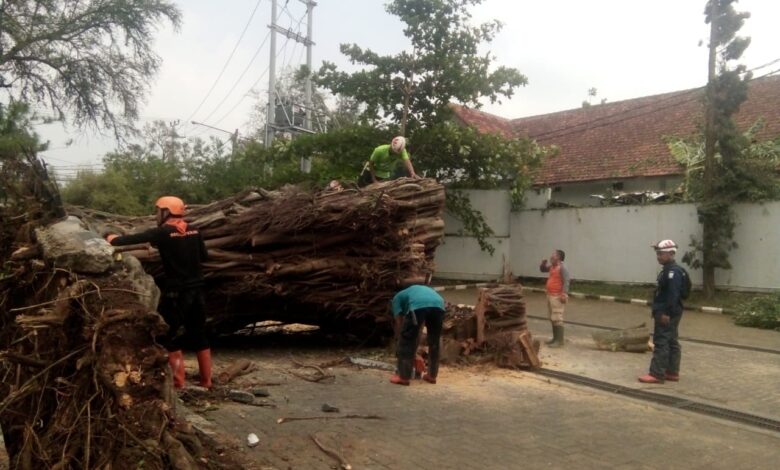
[390,285,445,385]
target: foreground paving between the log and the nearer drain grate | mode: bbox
[192,349,780,469]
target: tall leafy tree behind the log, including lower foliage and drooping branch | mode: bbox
[314,0,551,252]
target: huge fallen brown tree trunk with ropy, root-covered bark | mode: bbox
[68,178,445,334]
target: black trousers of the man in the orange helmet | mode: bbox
[158,289,209,351]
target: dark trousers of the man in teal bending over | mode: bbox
[397,307,444,380]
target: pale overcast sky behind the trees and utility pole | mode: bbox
[37,0,780,177]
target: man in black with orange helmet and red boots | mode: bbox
[106,196,211,388]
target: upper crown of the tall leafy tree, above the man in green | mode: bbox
[314,0,527,134]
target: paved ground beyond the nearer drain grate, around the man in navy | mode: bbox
[444,290,780,420]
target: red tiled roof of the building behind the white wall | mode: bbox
[452,76,780,185]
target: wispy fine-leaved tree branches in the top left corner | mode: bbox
[0,0,181,137]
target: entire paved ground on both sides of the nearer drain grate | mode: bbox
[0,290,780,470]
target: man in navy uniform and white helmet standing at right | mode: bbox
[639,240,687,383]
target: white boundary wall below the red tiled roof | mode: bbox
[436,191,780,290]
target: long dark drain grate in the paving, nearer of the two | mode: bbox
[534,368,780,432]
